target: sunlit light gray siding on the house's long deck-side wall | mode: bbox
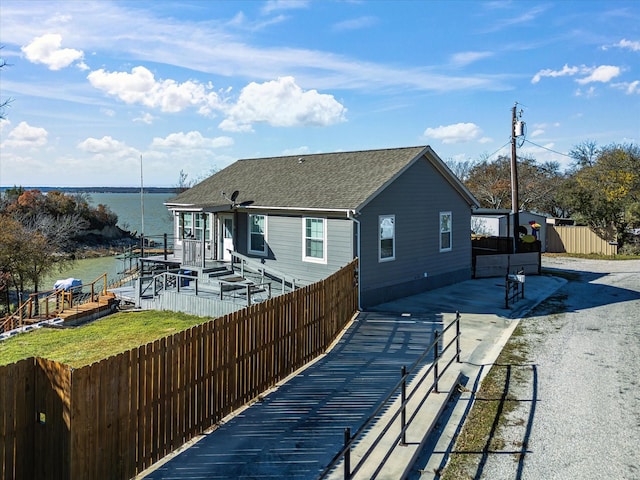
[236,212,355,284]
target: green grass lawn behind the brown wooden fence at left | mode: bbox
[0,311,210,368]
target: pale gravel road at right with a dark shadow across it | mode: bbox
[476,257,640,480]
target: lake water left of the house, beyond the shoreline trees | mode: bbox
[41,193,175,290]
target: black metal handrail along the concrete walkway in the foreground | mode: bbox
[318,312,461,480]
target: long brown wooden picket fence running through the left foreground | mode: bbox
[0,260,358,479]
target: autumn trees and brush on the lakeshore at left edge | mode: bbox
[0,187,132,311]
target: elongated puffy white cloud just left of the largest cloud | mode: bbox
[87,66,220,113]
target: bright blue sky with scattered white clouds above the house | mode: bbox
[0,0,640,187]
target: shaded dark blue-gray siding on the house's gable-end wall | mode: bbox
[359,160,471,306]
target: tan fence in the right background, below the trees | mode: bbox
[547,225,618,255]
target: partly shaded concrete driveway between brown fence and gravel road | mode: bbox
[140,276,564,479]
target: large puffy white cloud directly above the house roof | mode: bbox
[219,77,347,131]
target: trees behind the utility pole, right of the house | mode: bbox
[448,141,640,255]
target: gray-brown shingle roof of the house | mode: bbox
[166,147,478,210]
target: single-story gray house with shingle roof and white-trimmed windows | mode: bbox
[166,146,478,308]
